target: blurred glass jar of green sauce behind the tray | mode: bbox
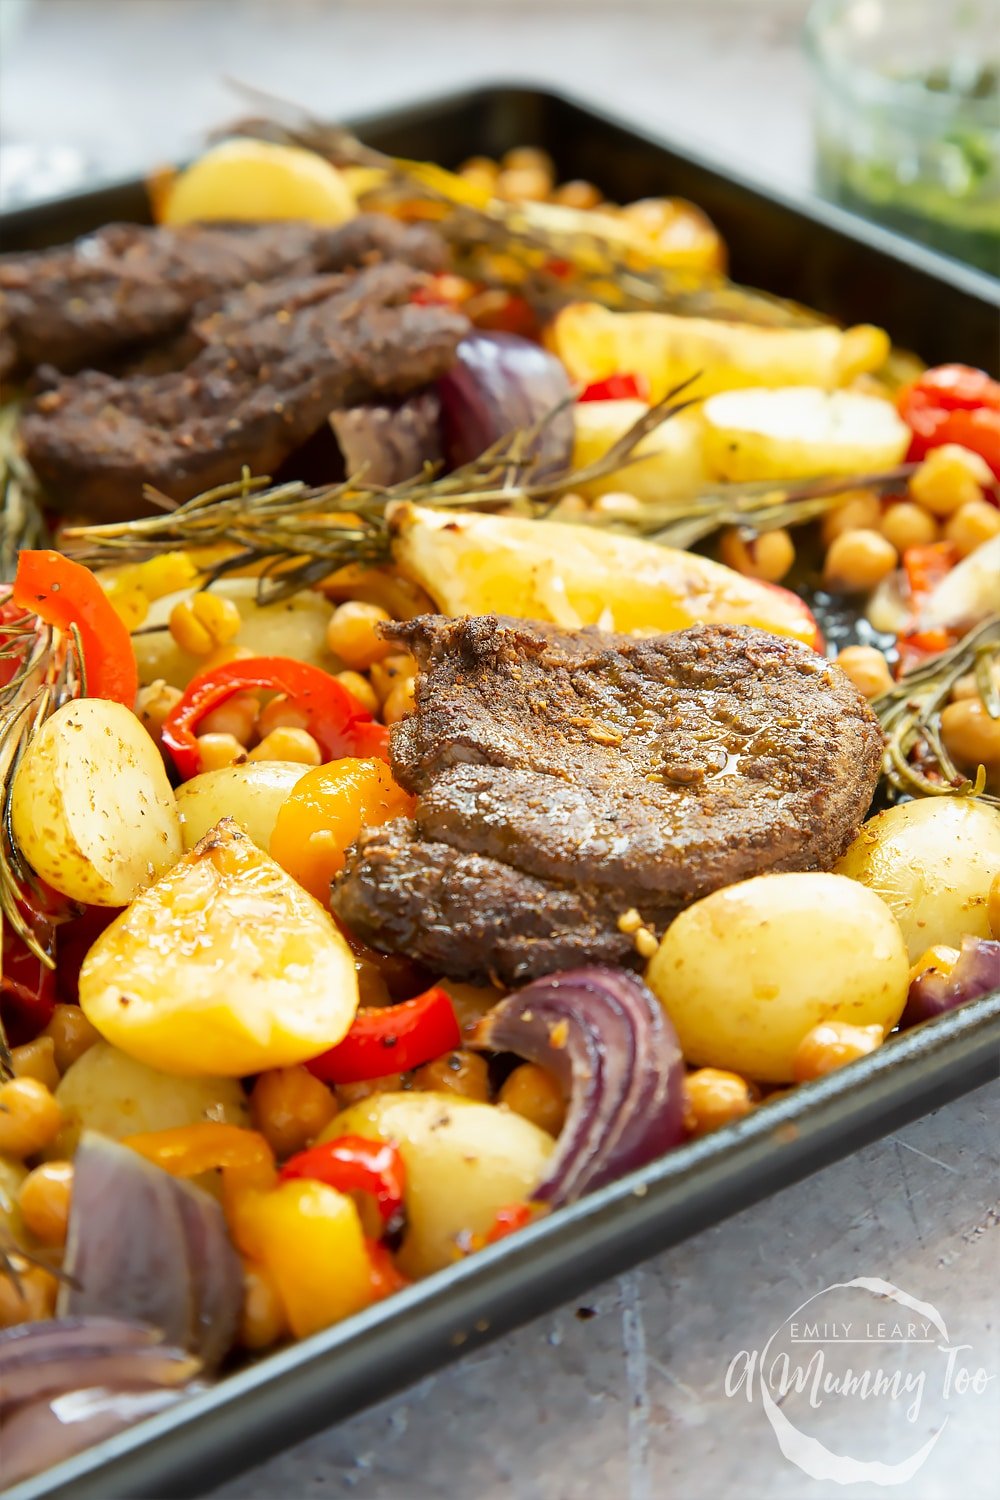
[805,0,1000,276]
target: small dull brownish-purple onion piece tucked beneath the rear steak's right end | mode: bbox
[330,390,444,486]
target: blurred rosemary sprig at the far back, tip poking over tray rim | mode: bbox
[226,84,825,327]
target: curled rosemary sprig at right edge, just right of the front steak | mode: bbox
[871,615,1000,806]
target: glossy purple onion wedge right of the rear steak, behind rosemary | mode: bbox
[438,333,573,473]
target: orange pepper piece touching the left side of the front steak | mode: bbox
[270,759,414,906]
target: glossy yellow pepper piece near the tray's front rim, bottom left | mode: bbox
[232,1181,375,1338]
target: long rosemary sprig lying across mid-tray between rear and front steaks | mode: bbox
[63,393,910,603]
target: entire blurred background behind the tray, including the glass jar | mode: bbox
[0,0,1000,275]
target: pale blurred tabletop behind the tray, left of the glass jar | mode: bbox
[0,0,851,203]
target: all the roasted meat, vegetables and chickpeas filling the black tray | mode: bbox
[0,126,1000,1481]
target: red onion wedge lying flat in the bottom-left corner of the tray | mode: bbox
[0,1317,201,1487]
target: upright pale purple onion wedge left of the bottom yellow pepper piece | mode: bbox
[58,1131,243,1368]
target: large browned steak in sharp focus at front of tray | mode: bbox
[333,617,882,984]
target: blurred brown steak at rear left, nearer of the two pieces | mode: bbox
[21,261,468,519]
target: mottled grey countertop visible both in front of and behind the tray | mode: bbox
[0,0,1000,1500]
